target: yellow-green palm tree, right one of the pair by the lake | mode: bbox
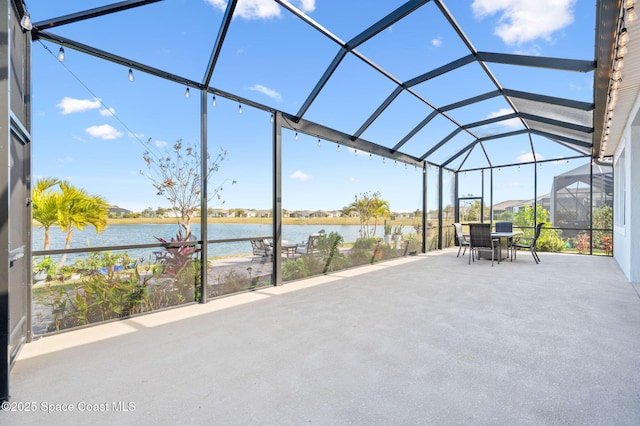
[58,181,109,267]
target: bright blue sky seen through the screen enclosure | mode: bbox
[27,0,595,211]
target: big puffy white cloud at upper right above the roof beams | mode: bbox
[472,0,576,44]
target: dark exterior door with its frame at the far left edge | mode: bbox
[0,0,31,401]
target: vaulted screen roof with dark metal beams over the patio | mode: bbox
[26,0,598,170]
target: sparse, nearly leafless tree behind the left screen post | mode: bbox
[140,138,236,235]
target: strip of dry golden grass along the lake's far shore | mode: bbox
[32,217,415,227]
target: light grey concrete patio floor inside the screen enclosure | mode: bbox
[5,249,640,425]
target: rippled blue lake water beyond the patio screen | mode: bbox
[32,224,370,264]
